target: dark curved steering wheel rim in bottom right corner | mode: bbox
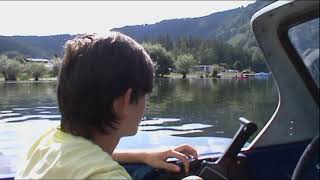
[292,135,319,180]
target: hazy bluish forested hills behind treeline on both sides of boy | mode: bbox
[0,1,271,59]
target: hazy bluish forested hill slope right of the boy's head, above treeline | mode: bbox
[113,1,272,47]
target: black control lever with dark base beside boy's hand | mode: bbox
[157,118,257,180]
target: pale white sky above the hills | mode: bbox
[0,0,254,36]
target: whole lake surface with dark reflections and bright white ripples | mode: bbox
[0,78,278,177]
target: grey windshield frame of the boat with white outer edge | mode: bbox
[248,1,319,150]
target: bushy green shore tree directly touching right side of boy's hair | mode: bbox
[142,43,173,77]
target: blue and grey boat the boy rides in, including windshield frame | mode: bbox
[0,0,319,180]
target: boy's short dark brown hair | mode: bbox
[57,32,153,139]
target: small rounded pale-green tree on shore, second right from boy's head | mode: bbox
[175,54,196,78]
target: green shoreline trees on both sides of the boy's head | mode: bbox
[0,35,268,81]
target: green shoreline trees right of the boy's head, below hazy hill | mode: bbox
[142,35,268,77]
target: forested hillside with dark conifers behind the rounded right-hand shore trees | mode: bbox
[111,1,278,74]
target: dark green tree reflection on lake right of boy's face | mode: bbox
[146,78,278,137]
